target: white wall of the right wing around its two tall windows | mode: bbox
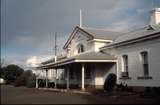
[114,38,160,87]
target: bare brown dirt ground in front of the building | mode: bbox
[1,85,160,104]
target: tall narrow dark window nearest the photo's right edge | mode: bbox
[141,51,149,76]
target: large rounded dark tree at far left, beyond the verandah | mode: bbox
[4,64,24,83]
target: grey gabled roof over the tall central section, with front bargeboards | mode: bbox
[63,26,120,48]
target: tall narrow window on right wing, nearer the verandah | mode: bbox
[122,55,128,77]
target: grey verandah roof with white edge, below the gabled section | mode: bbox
[40,52,116,69]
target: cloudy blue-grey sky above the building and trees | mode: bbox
[1,0,160,69]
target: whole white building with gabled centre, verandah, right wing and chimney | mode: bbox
[37,8,160,90]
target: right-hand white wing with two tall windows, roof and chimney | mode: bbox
[101,8,160,87]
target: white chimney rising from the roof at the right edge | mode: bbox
[150,8,160,30]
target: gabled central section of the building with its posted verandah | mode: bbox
[38,26,120,90]
